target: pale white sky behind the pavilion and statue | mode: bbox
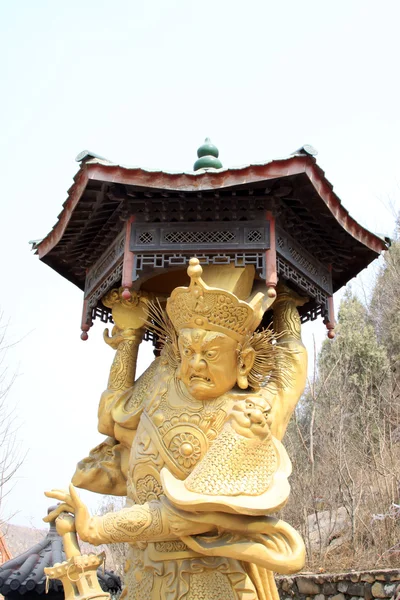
[0,0,400,527]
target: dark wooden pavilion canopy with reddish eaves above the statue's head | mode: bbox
[34,151,388,338]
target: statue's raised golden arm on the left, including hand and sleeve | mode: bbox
[72,288,154,496]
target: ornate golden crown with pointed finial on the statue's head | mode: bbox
[167,258,264,342]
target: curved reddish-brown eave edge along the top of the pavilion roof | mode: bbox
[34,154,388,258]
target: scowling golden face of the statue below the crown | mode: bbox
[179,329,238,400]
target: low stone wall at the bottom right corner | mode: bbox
[276,569,400,600]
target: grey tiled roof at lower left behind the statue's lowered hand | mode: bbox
[0,523,122,600]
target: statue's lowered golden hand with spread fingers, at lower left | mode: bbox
[43,483,92,540]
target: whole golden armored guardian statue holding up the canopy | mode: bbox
[46,258,307,600]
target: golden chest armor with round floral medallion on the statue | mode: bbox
[128,369,227,504]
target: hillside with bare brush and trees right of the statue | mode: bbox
[283,229,400,570]
